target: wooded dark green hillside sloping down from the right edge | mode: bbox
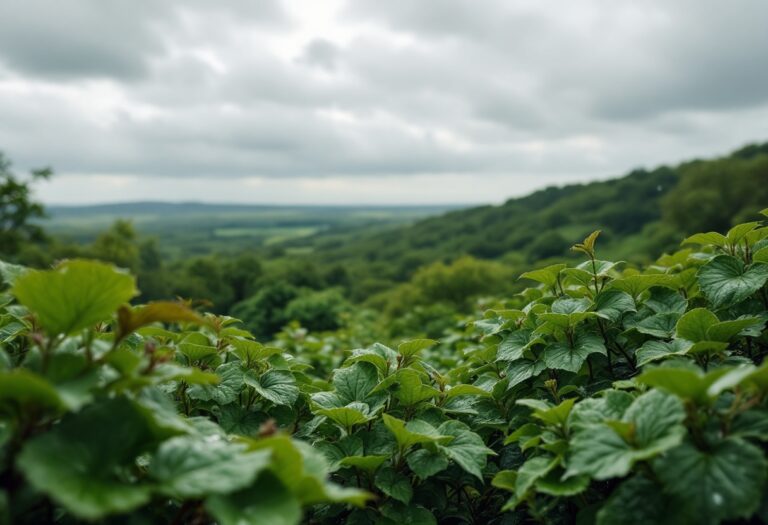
[287,139,768,280]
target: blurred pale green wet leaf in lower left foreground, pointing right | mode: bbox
[149,436,270,499]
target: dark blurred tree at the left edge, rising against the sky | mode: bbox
[0,152,53,258]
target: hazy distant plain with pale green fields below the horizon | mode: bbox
[42,202,455,257]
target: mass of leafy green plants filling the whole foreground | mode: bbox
[0,211,768,525]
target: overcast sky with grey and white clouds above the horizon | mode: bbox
[0,0,768,203]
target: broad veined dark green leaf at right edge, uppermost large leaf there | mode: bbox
[698,255,768,308]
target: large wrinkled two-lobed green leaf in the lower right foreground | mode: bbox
[566,390,686,480]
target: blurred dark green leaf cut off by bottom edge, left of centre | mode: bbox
[205,473,301,525]
